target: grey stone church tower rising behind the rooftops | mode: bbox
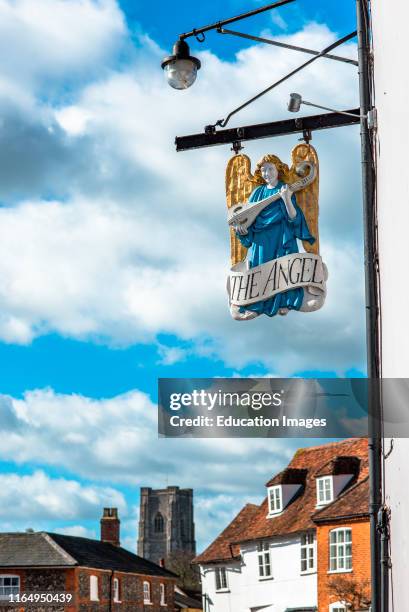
[138,487,196,563]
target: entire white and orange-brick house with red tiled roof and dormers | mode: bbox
[195,439,370,612]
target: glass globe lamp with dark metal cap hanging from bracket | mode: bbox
[162,38,201,89]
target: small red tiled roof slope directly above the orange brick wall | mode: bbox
[313,477,369,523]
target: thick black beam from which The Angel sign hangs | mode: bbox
[175,108,359,151]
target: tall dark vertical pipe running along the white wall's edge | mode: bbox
[356,0,387,612]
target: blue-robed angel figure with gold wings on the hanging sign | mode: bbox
[226,145,325,320]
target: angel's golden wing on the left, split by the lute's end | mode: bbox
[226,155,256,266]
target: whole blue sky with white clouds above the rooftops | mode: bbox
[0,0,366,550]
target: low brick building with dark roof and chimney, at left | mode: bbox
[0,508,176,612]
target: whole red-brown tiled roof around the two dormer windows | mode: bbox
[195,438,368,563]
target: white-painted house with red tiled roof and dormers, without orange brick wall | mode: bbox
[195,439,369,612]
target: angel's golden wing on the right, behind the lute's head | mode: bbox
[290,143,320,255]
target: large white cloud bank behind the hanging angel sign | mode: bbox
[0,16,364,375]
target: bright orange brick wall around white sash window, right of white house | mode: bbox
[317,520,371,612]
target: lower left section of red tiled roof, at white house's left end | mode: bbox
[193,504,259,563]
